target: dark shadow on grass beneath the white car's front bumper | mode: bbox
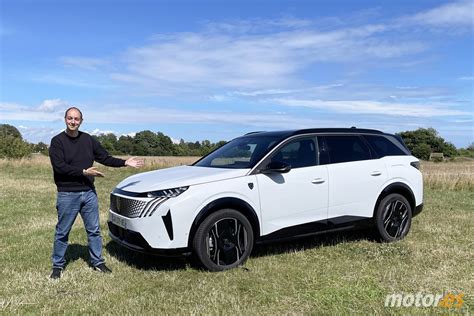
[105,241,189,271]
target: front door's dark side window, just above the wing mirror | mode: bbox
[271,137,318,169]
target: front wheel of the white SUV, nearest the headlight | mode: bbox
[193,209,254,272]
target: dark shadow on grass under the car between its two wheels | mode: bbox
[251,229,376,257]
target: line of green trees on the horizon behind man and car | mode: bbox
[0,124,474,160]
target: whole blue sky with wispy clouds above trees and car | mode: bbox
[0,0,474,147]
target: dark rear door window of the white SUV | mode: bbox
[320,135,372,163]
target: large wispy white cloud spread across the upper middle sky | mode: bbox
[111,24,426,94]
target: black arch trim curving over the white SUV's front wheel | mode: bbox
[188,197,260,249]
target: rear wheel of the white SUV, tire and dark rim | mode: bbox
[375,193,412,242]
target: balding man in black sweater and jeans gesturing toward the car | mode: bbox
[49,107,143,279]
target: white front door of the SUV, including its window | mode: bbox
[256,136,328,235]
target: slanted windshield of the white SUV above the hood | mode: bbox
[194,135,282,169]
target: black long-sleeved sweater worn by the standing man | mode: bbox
[49,132,125,192]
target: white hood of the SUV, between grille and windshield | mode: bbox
[117,166,250,193]
